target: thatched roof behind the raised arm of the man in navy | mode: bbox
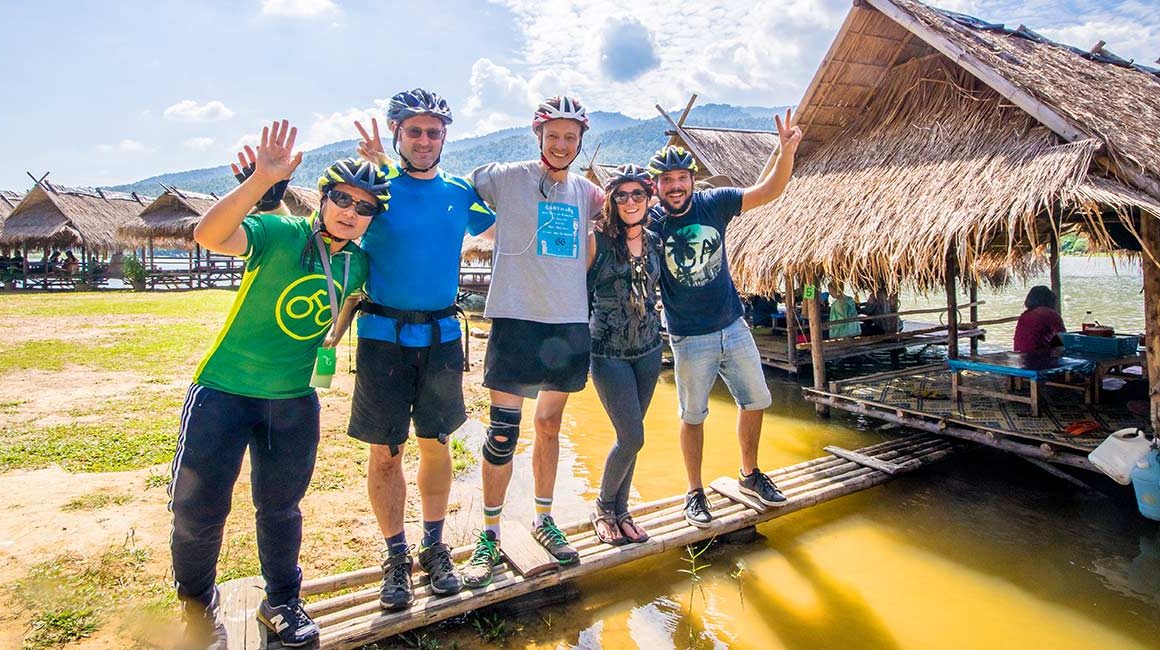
[668,125,778,187]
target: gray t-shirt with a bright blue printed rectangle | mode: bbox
[471,160,604,323]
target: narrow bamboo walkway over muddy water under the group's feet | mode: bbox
[222,435,955,650]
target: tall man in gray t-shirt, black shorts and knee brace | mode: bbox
[463,96,604,587]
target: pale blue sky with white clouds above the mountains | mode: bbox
[0,0,1160,190]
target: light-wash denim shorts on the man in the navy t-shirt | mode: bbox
[668,318,773,425]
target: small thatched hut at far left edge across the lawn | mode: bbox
[0,180,152,288]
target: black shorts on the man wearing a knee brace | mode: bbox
[484,318,592,398]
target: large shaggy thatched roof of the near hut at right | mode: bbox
[728,0,1160,293]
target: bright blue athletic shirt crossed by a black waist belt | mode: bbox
[358,165,495,347]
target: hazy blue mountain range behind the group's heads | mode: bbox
[104,103,784,196]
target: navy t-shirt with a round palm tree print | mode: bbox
[648,187,744,337]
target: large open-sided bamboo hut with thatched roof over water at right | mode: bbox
[727,0,1160,469]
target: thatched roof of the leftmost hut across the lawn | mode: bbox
[0,181,152,251]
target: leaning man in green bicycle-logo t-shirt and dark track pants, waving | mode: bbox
[169,121,390,650]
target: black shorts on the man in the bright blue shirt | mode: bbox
[347,338,467,445]
